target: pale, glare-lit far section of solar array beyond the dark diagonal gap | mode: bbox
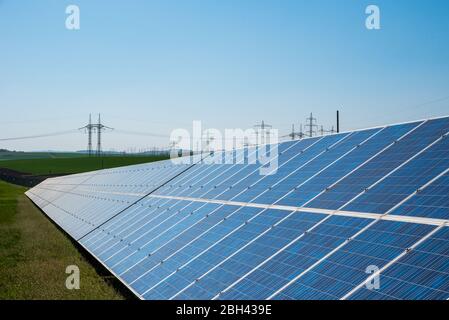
[27,159,196,239]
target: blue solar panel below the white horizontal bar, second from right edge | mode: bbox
[276,221,435,300]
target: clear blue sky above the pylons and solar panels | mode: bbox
[0,0,449,150]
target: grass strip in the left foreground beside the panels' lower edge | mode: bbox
[0,181,123,299]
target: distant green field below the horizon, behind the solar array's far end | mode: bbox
[0,156,166,175]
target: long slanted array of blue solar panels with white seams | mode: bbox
[27,117,449,299]
